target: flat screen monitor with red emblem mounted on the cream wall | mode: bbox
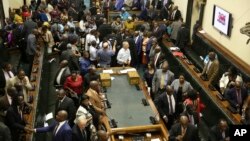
[213,5,232,36]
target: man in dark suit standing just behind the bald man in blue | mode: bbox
[55,89,76,127]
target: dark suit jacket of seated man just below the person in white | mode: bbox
[226,88,247,107]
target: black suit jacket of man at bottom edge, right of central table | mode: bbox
[169,123,200,141]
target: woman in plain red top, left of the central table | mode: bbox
[63,71,83,96]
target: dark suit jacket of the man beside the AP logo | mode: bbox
[210,125,229,141]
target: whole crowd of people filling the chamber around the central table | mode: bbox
[0,0,250,141]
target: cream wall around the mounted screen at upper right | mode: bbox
[203,0,250,65]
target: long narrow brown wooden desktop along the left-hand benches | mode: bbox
[26,41,44,141]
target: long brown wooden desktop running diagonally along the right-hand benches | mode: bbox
[162,37,241,124]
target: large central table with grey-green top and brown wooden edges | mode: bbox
[98,67,168,141]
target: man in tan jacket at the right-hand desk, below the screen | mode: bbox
[201,52,219,85]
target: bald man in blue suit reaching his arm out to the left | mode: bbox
[32,110,72,141]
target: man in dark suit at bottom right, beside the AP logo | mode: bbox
[210,119,230,141]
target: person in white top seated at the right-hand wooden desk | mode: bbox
[220,67,242,94]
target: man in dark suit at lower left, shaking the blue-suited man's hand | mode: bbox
[5,95,30,141]
